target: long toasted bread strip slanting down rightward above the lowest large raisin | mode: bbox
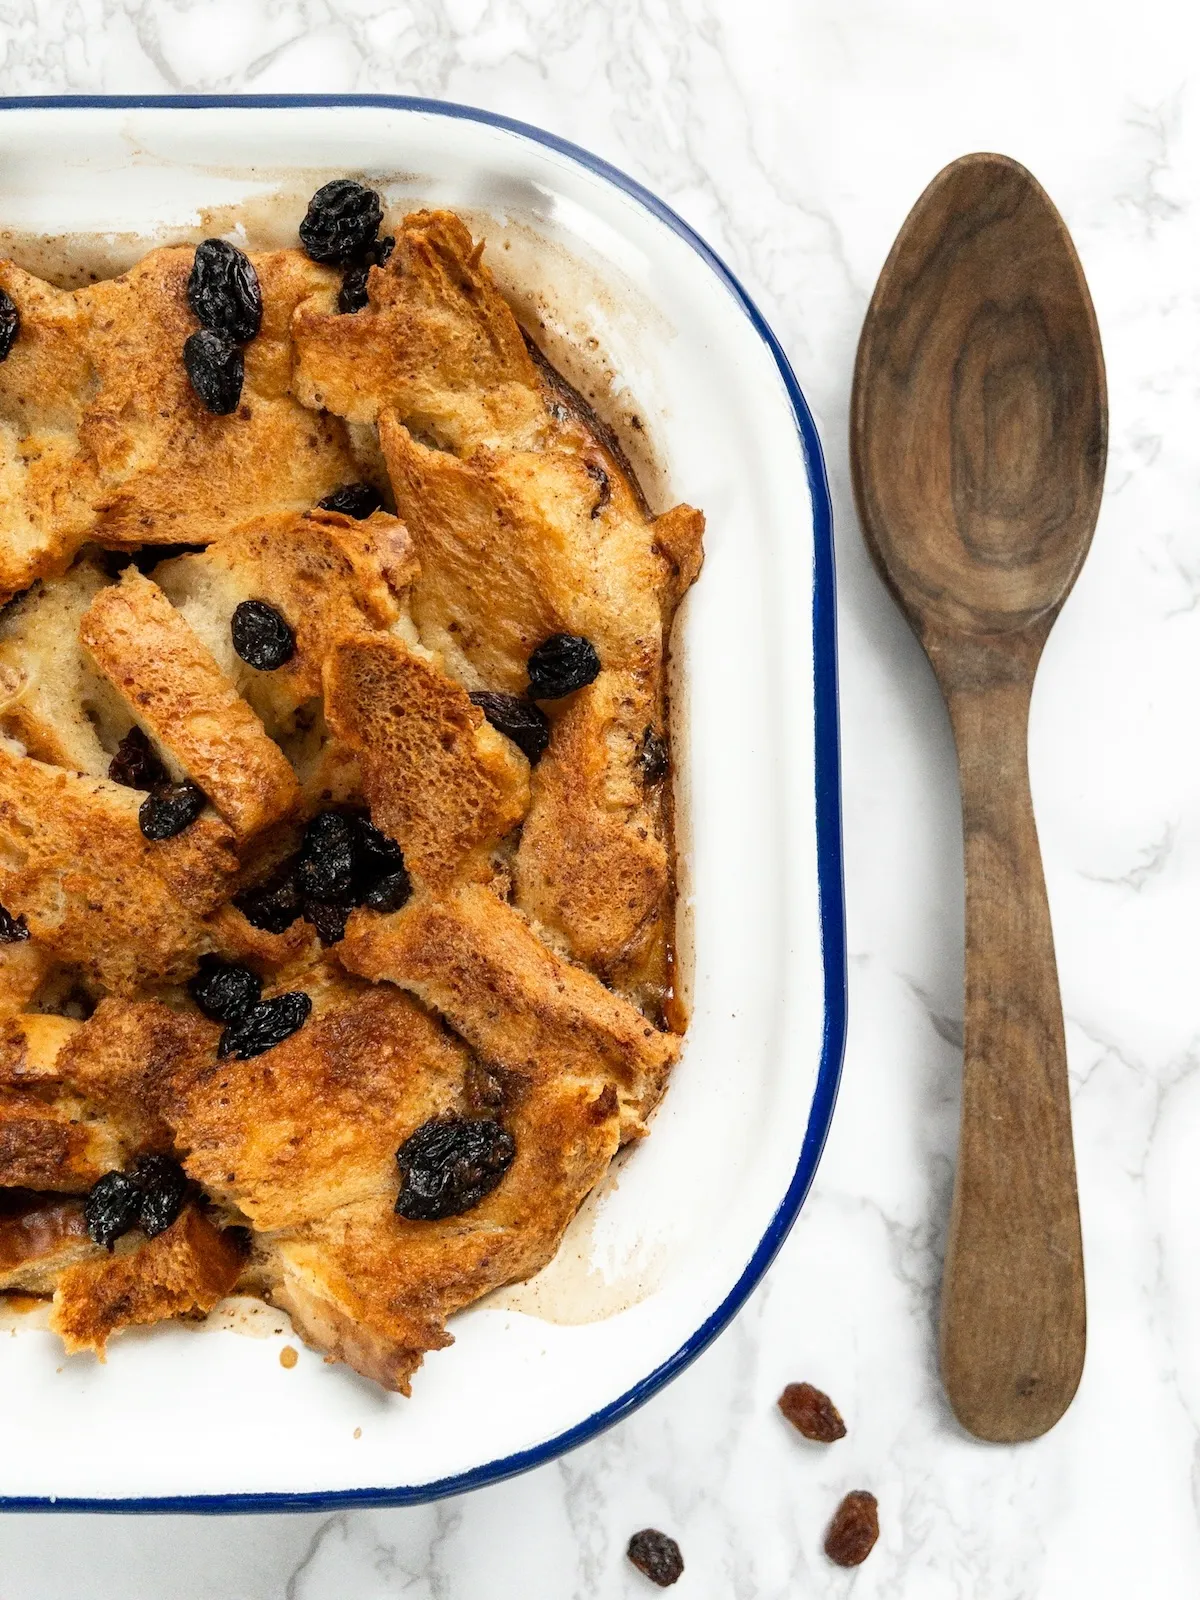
[338,883,680,1138]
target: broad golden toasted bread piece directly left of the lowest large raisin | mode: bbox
[170,966,469,1230]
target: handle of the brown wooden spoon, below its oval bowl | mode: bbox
[939,643,1086,1443]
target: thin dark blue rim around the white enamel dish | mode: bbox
[0,94,846,1515]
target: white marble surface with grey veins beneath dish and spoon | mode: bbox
[0,0,1200,1600]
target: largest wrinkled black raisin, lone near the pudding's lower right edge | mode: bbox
[395,1117,517,1222]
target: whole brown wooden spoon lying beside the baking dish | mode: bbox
[851,155,1107,1442]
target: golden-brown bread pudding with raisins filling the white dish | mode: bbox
[0,179,704,1394]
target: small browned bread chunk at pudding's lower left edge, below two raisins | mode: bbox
[50,1205,243,1360]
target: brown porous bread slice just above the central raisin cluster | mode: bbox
[325,634,530,885]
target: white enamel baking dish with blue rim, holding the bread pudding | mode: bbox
[0,96,845,1512]
